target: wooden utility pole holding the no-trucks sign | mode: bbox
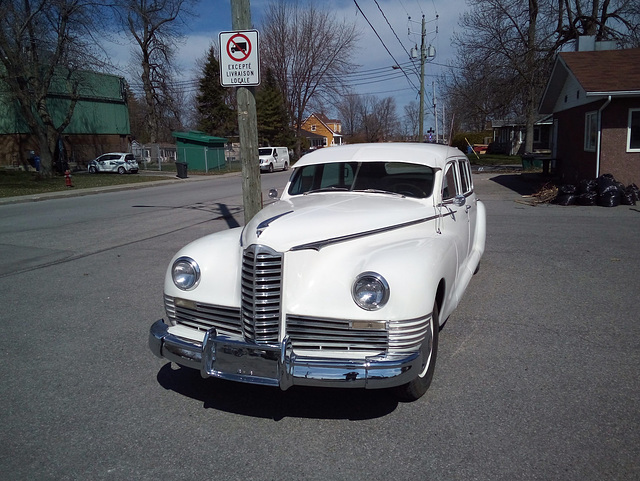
[231,0,262,224]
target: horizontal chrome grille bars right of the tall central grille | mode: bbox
[287,316,389,354]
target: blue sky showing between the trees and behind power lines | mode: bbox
[104,0,466,129]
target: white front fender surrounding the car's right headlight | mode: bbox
[283,226,457,320]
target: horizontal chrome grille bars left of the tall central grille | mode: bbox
[164,295,242,337]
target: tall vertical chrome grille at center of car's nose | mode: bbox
[242,245,282,344]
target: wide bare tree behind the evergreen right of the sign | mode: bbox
[261,0,357,155]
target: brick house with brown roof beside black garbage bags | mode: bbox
[539,43,640,185]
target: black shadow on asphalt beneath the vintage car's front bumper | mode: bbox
[157,363,398,421]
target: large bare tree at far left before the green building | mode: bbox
[0,0,106,176]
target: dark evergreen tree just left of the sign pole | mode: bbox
[196,46,237,137]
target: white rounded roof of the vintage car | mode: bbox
[294,142,464,169]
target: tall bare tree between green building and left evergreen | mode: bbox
[116,0,192,143]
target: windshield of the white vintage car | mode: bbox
[289,162,433,199]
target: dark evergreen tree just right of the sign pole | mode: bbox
[256,69,295,147]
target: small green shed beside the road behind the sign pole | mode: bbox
[171,130,227,172]
